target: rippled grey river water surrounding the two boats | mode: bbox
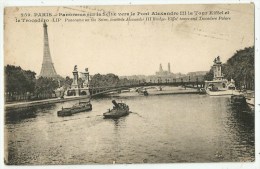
[5,94,255,164]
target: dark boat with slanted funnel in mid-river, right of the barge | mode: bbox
[103,100,129,118]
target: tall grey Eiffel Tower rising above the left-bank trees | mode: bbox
[39,22,59,78]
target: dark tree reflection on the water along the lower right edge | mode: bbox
[226,99,255,161]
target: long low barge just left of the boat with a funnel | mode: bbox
[57,101,92,117]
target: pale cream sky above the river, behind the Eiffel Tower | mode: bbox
[4,4,254,76]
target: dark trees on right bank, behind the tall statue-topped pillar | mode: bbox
[204,46,255,90]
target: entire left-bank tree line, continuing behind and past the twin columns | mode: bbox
[5,65,138,101]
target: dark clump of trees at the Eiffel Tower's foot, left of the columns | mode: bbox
[4,65,59,101]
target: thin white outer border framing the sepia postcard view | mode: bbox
[0,0,260,169]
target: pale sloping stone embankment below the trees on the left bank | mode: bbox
[5,96,90,111]
